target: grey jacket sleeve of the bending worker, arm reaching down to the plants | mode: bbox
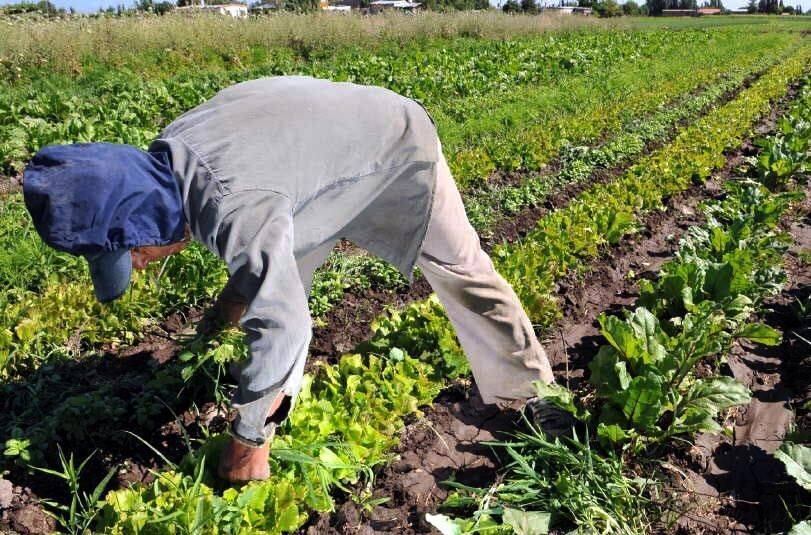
[216,191,312,444]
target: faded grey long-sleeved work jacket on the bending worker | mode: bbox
[149,76,438,442]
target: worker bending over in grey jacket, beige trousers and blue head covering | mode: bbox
[23,77,566,481]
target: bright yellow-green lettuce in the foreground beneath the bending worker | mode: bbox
[98,301,461,534]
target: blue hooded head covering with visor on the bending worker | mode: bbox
[23,143,185,302]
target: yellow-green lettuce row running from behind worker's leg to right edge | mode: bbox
[495,49,811,326]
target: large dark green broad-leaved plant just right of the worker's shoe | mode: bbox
[589,307,749,449]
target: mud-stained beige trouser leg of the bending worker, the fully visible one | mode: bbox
[418,140,554,403]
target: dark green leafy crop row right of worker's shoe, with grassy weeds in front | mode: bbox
[432,81,811,534]
